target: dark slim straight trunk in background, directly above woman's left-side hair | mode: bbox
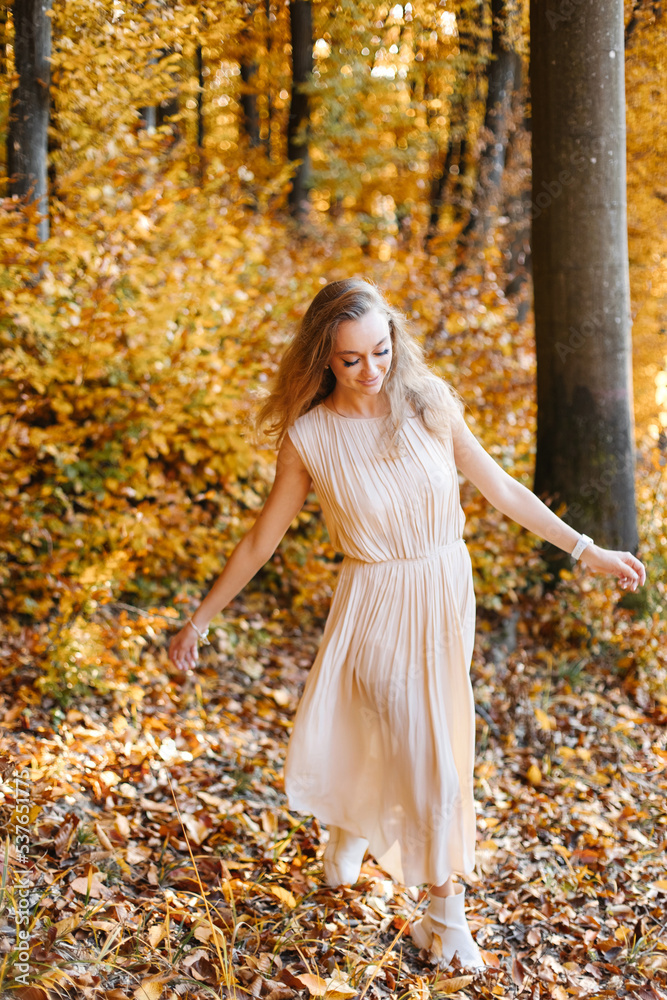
[287,0,313,217]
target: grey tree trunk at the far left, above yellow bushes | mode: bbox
[7,0,52,240]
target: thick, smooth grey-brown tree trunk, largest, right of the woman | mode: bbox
[530,0,638,558]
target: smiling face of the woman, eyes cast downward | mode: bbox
[329,309,392,396]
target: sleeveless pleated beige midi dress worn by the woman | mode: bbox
[285,404,475,885]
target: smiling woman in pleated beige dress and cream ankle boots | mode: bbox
[169,279,646,968]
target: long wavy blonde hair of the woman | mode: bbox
[256,278,464,457]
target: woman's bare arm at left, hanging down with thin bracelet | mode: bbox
[169,436,311,668]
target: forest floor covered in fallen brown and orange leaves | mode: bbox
[0,588,667,1000]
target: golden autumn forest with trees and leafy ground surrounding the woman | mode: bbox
[0,0,667,1000]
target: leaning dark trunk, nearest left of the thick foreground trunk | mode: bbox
[457,0,521,258]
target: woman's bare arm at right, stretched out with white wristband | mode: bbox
[453,421,646,590]
